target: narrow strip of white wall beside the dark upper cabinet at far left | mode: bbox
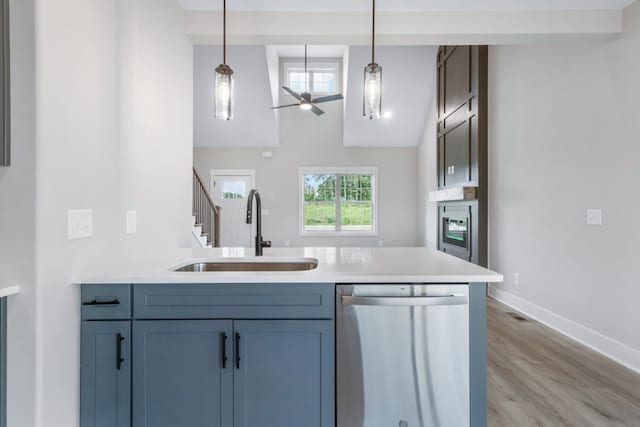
[0,0,36,427]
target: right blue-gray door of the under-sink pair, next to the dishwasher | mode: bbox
[233,320,335,427]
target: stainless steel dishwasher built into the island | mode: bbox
[336,284,470,427]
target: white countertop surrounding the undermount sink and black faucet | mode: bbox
[74,247,503,284]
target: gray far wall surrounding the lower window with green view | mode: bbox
[193,102,418,246]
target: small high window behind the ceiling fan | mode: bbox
[283,62,340,95]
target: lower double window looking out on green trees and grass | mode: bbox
[300,168,377,235]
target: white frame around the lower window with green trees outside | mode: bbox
[298,166,378,237]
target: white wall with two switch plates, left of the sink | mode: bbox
[31,0,193,427]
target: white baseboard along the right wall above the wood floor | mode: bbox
[489,285,640,373]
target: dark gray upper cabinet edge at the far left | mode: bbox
[0,0,11,166]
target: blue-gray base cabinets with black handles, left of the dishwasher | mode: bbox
[81,284,335,427]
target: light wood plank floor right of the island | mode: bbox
[487,299,640,427]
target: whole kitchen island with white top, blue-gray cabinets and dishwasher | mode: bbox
[77,248,502,427]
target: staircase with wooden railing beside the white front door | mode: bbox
[192,168,220,248]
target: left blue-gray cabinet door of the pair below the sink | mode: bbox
[133,320,233,427]
